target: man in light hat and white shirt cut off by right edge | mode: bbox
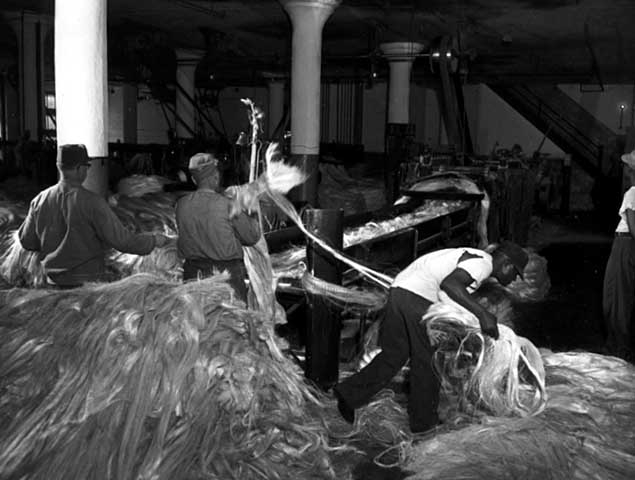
[602,150,635,360]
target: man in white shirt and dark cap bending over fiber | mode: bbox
[334,242,528,433]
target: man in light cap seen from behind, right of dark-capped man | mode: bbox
[176,153,261,302]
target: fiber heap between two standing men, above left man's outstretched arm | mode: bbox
[108,192,177,235]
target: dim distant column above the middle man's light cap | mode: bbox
[175,48,204,138]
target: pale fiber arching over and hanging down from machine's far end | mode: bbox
[397,172,490,248]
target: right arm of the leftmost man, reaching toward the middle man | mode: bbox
[91,199,159,255]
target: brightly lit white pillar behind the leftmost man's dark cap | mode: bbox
[55,0,108,195]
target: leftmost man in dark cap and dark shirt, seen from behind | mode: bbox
[18,145,169,288]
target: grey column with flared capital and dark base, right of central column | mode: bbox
[379,42,423,205]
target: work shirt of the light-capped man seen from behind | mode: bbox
[176,189,260,261]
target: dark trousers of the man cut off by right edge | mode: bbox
[602,236,635,356]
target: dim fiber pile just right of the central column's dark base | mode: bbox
[318,163,386,215]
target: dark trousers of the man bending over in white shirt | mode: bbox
[335,288,440,432]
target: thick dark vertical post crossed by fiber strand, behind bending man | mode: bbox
[304,209,344,390]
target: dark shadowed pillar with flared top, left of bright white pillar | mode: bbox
[5,11,50,140]
